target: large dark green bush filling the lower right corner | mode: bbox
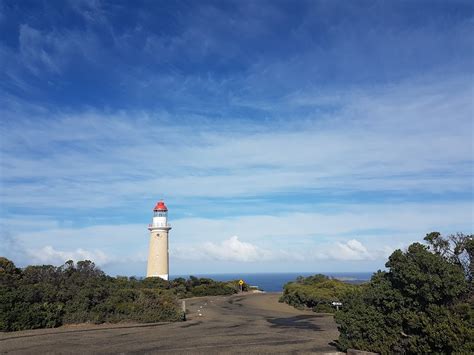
[336,233,474,354]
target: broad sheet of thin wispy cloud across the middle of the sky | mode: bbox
[2,74,472,211]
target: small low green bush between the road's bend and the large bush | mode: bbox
[280,275,357,313]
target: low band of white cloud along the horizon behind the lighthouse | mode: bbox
[0,202,472,273]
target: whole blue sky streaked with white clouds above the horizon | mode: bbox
[0,0,474,275]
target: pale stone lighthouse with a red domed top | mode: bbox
[146,201,171,280]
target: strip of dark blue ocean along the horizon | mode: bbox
[170,272,373,292]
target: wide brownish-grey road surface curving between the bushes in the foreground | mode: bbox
[0,293,338,354]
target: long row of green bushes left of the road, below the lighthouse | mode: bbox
[0,257,247,331]
